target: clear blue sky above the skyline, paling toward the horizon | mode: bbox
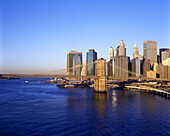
[0,0,170,73]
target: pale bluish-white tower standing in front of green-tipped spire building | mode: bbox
[132,58,141,77]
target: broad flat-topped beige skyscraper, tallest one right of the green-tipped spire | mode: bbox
[143,41,157,67]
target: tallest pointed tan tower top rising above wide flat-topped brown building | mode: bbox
[116,40,126,56]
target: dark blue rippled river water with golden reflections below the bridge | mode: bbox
[0,78,170,136]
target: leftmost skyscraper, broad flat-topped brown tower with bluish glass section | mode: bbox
[67,51,82,75]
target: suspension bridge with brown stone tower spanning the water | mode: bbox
[0,59,170,93]
